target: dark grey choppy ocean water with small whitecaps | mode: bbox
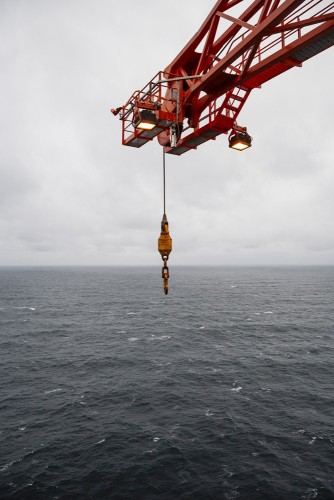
[0,266,334,500]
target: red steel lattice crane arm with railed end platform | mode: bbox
[116,0,334,155]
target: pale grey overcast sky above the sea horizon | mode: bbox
[0,0,334,266]
